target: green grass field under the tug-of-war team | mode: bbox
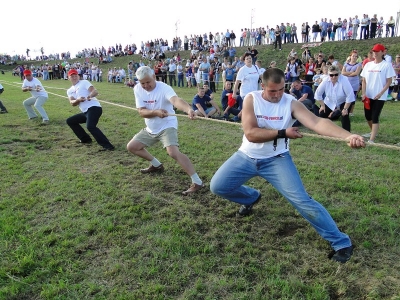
[0,39,400,300]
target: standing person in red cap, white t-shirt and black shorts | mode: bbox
[360,44,396,144]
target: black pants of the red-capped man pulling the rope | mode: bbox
[67,106,114,148]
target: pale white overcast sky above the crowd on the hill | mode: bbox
[0,0,400,57]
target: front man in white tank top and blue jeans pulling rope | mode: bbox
[210,68,365,263]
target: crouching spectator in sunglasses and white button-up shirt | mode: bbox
[314,66,355,131]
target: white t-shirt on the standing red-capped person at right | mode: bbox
[360,60,396,101]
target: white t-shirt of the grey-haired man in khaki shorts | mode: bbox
[133,81,178,134]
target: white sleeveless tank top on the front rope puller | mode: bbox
[239,91,296,159]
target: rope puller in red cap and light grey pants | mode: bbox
[22,69,49,124]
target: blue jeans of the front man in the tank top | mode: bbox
[210,151,351,250]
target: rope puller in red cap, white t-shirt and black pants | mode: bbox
[67,69,115,151]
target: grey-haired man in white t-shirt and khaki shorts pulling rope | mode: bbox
[127,66,204,195]
